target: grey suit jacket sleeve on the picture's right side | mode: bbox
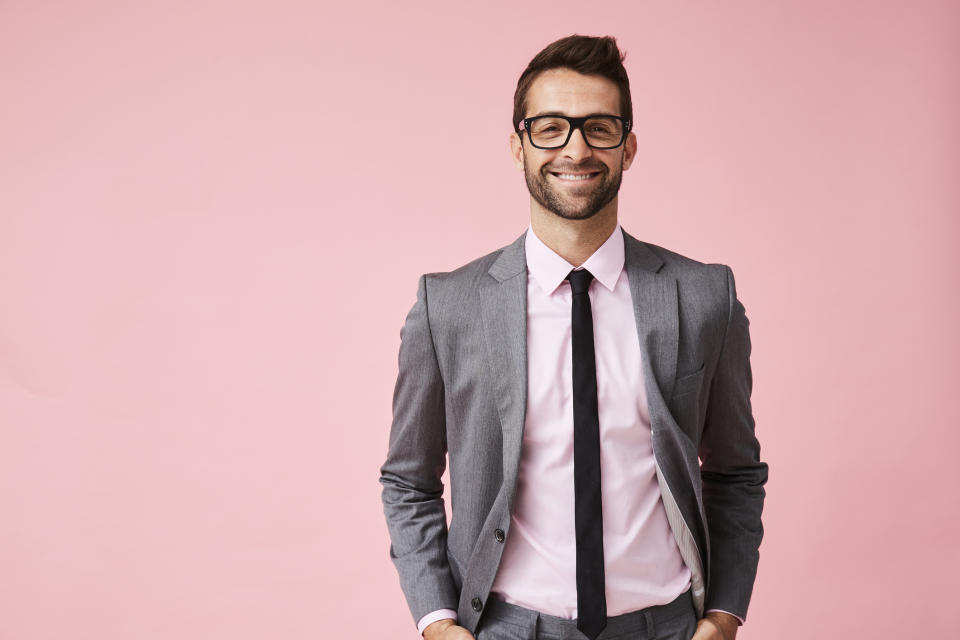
[699,265,767,619]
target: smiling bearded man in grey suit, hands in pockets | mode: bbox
[380,36,767,640]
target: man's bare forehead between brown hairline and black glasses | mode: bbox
[524,68,623,117]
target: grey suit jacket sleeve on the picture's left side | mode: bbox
[380,275,459,624]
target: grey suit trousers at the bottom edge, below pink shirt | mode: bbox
[476,590,697,640]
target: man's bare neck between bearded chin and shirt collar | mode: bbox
[530,198,617,267]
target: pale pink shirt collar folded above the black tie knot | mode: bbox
[524,222,624,296]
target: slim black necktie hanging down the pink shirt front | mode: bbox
[567,269,607,640]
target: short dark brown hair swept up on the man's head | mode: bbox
[513,35,633,131]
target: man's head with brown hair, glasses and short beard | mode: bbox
[510,36,637,220]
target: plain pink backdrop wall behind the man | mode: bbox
[0,0,960,640]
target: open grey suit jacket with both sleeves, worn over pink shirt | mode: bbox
[380,231,767,632]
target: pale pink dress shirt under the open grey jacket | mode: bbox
[417,224,744,633]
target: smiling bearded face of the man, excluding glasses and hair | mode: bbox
[511,68,637,220]
